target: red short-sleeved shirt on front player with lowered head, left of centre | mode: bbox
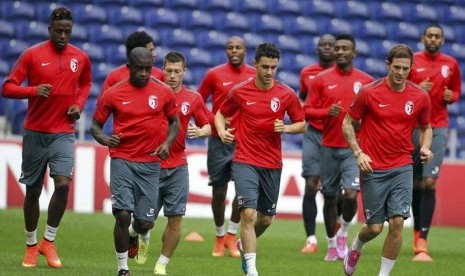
[94,78,177,162]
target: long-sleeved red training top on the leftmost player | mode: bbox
[2,40,92,133]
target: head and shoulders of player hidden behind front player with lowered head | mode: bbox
[100,31,164,94]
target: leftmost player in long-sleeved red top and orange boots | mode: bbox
[2,7,92,268]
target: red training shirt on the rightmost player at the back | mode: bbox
[409,51,462,128]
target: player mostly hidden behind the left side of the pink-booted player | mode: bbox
[299,34,335,253]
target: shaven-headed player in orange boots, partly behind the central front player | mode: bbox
[199,36,255,258]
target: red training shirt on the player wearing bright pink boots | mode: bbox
[304,66,374,148]
